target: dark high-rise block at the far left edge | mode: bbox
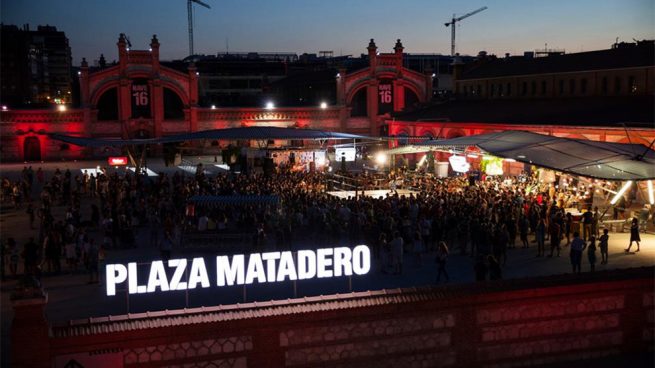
[0,25,72,106]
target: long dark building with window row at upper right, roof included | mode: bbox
[455,41,655,99]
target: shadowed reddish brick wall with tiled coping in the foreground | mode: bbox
[12,268,655,368]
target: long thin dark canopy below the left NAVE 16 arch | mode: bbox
[50,127,368,147]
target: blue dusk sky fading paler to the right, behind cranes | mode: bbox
[0,0,655,65]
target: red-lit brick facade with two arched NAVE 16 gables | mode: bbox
[0,35,655,161]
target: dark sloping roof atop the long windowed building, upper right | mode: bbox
[460,41,655,80]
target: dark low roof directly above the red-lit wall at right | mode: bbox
[395,96,655,128]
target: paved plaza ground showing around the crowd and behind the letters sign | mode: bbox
[0,162,655,366]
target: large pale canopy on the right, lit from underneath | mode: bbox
[415,130,655,180]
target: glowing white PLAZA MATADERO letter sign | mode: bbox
[105,245,371,296]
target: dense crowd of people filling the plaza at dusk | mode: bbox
[2,167,639,282]
